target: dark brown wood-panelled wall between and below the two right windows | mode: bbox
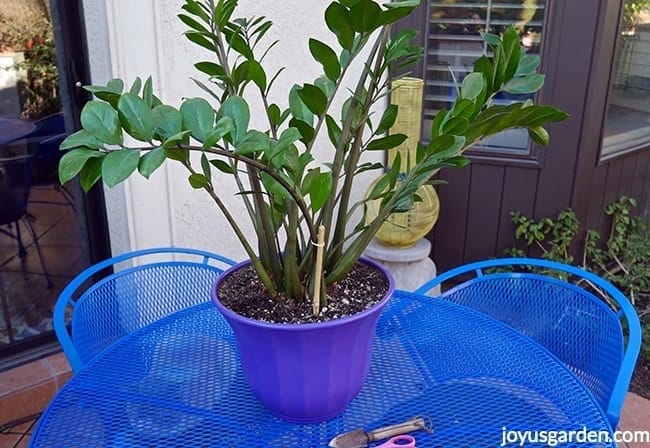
[404,0,650,271]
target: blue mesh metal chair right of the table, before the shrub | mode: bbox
[415,258,641,428]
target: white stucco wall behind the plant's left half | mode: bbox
[84,0,381,259]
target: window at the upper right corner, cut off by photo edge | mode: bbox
[602,0,650,156]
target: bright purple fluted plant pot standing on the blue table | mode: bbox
[212,259,394,423]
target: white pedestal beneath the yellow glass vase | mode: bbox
[363,239,440,296]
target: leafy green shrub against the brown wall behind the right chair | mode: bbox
[506,196,650,359]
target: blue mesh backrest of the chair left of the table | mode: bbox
[54,247,234,372]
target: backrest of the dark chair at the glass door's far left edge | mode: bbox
[0,157,31,225]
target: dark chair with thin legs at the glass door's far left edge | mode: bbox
[0,156,52,288]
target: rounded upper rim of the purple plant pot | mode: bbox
[210,257,395,331]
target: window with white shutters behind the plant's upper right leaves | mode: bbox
[423,0,546,155]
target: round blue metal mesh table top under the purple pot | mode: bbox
[31,292,615,448]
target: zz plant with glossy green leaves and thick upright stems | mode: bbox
[59,0,567,304]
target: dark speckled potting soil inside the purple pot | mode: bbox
[219,263,388,324]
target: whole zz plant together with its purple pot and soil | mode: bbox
[59,0,566,422]
